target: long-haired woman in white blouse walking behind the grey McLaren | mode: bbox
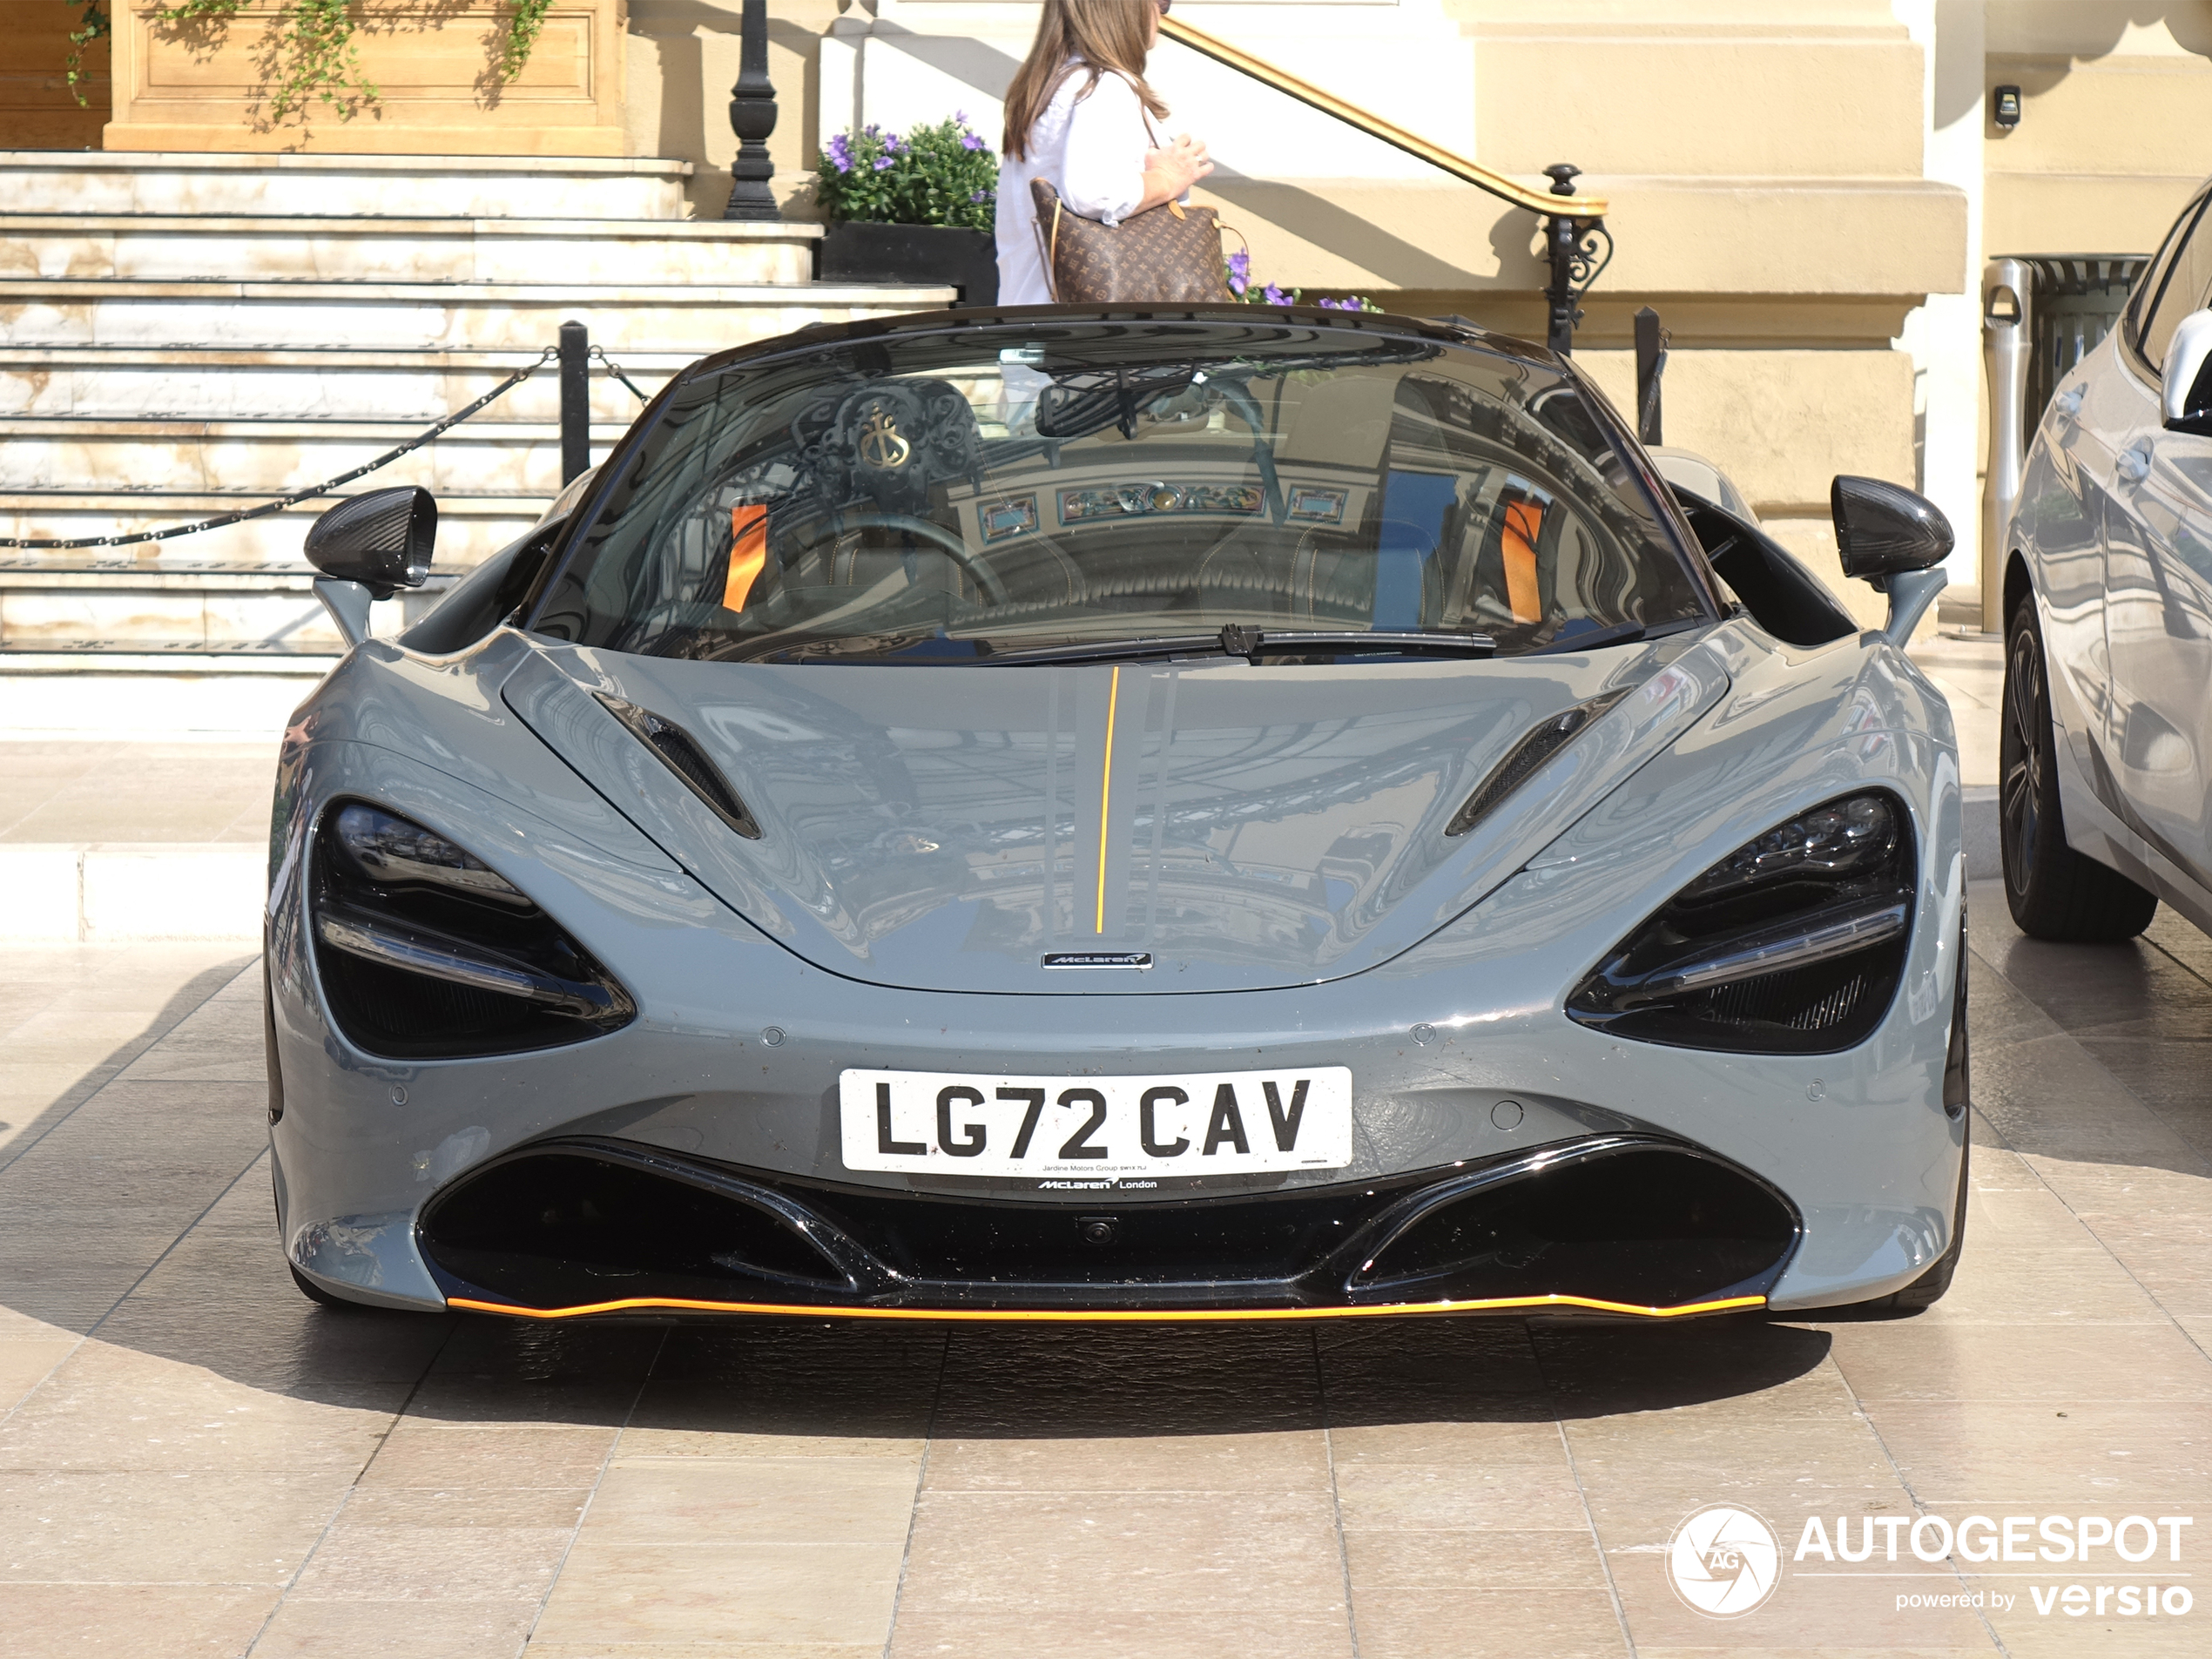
[998,0,1214,306]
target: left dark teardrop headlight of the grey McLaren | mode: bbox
[307,800,637,1060]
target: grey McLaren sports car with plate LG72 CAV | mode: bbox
[266,306,1966,1320]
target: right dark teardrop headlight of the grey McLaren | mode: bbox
[1566,790,1916,1053]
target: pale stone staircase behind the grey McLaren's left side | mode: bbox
[0,151,951,672]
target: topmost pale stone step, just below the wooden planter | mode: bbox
[0,151,692,221]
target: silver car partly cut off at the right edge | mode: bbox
[2000,190,2212,941]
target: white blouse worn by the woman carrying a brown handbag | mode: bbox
[998,64,1155,306]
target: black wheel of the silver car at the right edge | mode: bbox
[1998,595,2159,945]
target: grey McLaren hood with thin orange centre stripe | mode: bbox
[504,637,1728,995]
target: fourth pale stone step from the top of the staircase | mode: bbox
[0,339,699,427]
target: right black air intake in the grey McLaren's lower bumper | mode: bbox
[1349,1148,1796,1307]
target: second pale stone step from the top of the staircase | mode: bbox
[0,218,823,287]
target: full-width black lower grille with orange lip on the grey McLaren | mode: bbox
[418,1135,1798,1320]
